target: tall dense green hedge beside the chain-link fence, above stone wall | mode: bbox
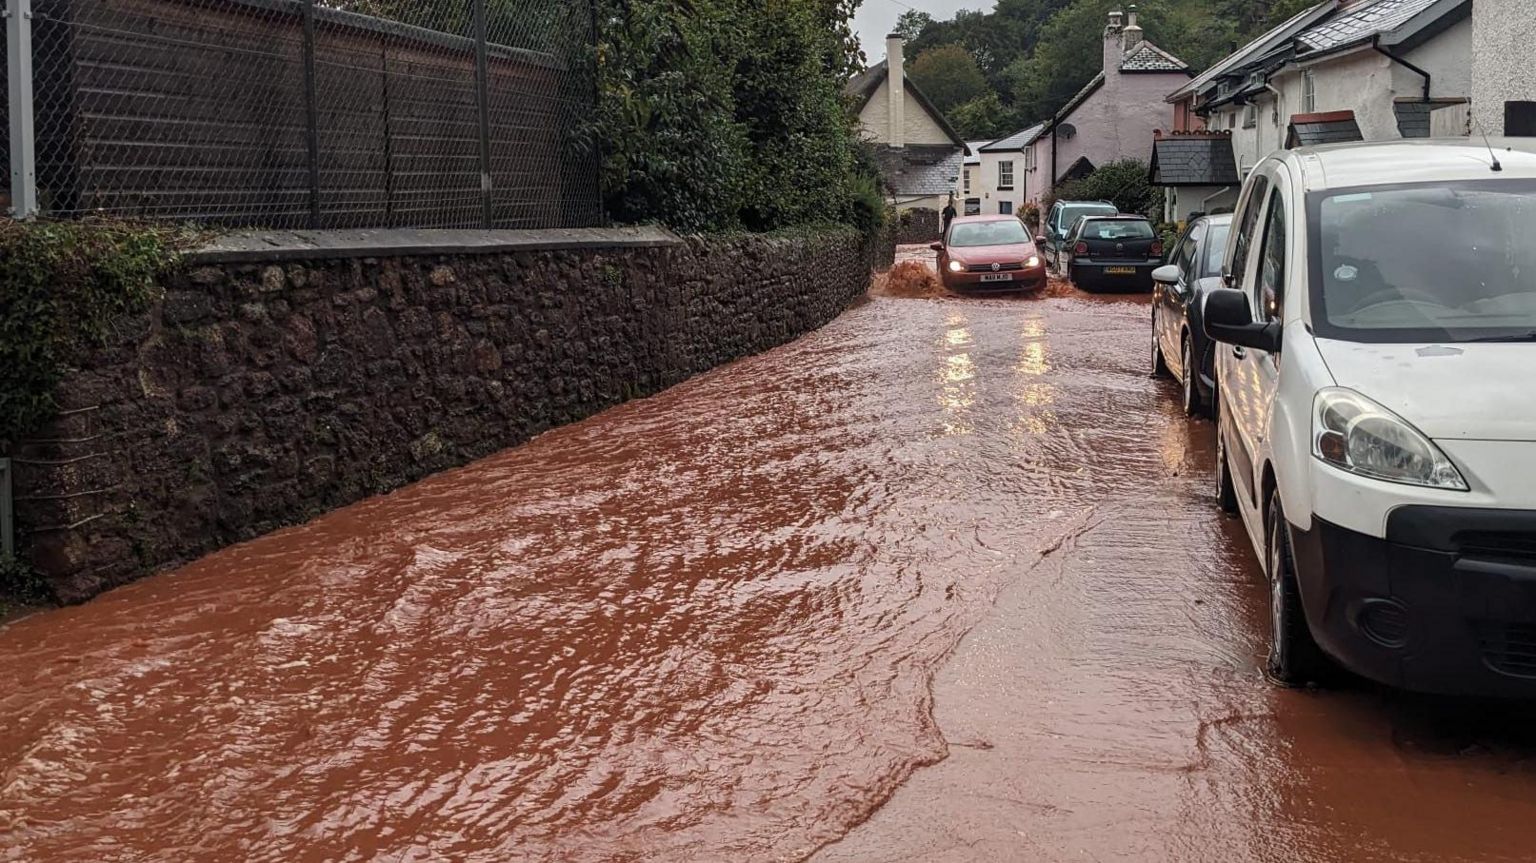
[591,0,883,232]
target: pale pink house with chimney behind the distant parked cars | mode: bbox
[1028,6,1190,201]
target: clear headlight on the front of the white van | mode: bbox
[1312,387,1468,491]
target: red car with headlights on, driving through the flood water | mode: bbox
[934,215,1046,292]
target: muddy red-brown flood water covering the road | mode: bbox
[0,265,1536,863]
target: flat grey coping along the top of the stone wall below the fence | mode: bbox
[187,226,684,264]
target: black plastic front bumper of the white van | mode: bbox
[1292,505,1536,697]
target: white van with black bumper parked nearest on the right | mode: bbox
[1204,137,1536,697]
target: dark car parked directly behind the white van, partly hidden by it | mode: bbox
[1152,215,1232,416]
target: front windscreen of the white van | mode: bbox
[1307,180,1536,342]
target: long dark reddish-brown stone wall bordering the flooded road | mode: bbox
[11,225,877,602]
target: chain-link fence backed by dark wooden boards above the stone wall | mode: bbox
[0,0,602,227]
